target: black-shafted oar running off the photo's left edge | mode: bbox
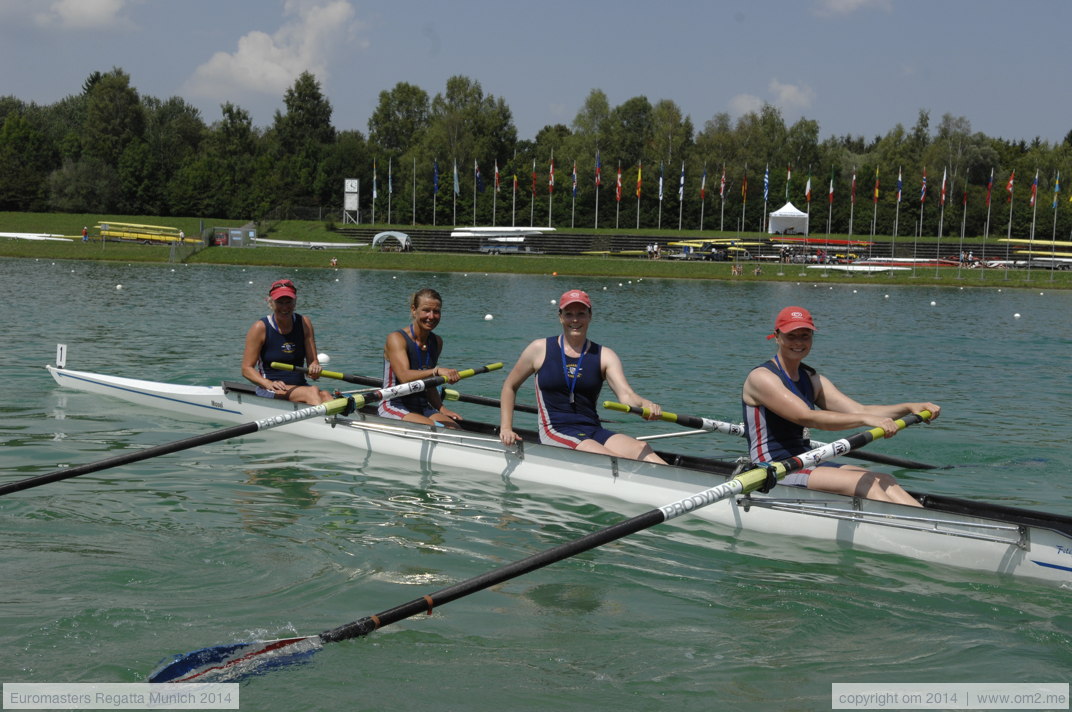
[0,364,503,496]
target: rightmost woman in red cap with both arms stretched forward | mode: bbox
[741,307,940,507]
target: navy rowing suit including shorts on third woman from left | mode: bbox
[536,336,614,448]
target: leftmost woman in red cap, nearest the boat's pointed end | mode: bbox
[242,280,331,405]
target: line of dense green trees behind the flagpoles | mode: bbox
[0,68,1072,239]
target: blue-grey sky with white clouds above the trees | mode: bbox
[0,0,1072,143]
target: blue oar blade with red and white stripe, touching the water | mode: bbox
[149,636,324,682]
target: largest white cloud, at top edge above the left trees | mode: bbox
[183,0,367,101]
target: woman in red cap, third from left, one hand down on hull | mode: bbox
[498,290,664,462]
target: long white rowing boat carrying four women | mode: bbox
[46,366,1072,588]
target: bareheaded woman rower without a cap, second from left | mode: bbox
[379,288,462,427]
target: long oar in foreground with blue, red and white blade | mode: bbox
[149,411,930,682]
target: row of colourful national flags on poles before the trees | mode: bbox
[372,151,1072,209]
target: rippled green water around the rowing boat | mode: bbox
[0,261,1072,711]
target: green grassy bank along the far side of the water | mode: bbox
[0,212,1072,288]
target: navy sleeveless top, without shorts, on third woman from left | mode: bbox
[536,337,604,428]
